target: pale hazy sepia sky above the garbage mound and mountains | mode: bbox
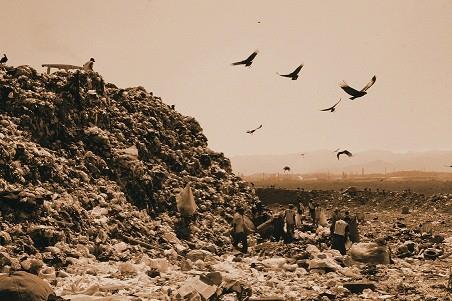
[0,0,452,155]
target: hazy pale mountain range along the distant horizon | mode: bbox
[230,150,452,175]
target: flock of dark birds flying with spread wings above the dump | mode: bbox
[232,50,377,160]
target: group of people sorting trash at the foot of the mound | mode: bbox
[231,201,359,254]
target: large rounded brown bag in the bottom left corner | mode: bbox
[0,271,53,301]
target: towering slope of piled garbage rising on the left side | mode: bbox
[0,66,255,262]
